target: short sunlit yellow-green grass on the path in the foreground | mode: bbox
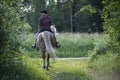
[32,58,93,80]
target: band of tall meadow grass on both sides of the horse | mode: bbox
[22,33,102,57]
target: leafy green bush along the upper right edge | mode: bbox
[102,0,120,52]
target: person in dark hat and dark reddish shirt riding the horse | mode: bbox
[32,10,60,48]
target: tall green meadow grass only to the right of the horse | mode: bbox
[57,33,94,57]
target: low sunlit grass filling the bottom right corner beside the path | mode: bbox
[89,52,120,80]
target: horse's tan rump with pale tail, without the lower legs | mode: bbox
[38,31,56,59]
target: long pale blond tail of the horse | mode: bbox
[42,31,56,60]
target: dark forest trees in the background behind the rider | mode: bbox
[24,0,103,32]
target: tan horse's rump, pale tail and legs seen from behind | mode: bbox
[37,31,56,70]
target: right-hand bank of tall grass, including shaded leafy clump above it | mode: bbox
[89,33,120,80]
